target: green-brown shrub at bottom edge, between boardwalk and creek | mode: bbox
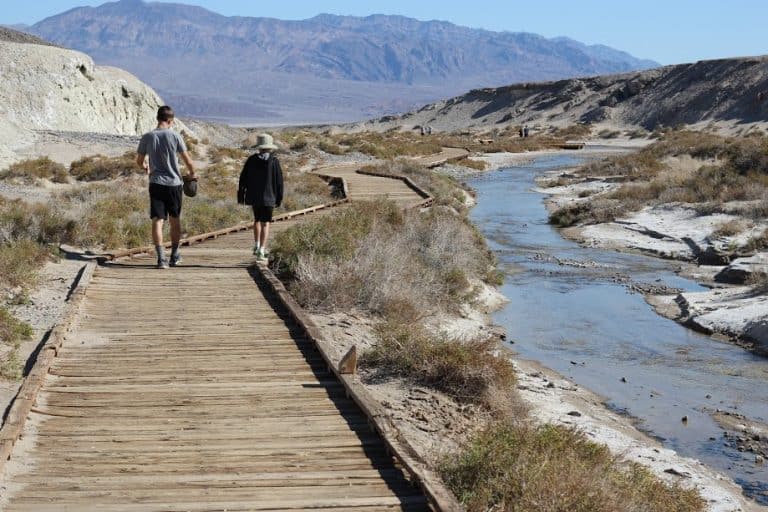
[440,421,706,512]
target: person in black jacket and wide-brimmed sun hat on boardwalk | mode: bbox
[237,133,283,260]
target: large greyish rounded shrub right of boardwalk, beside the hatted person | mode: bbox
[272,202,493,319]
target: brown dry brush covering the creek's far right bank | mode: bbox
[550,131,768,226]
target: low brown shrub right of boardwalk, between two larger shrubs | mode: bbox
[361,322,515,406]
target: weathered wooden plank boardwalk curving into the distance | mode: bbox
[0,158,462,512]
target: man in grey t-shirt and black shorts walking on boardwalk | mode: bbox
[136,106,195,268]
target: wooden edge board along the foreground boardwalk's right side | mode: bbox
[252,265,464,512]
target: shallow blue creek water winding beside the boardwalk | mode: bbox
[468,155,768,505]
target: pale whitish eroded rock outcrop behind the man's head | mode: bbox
[0,34,168,169]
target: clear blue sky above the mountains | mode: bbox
[6,0,768,64]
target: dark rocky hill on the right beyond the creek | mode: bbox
[370,56,768,130]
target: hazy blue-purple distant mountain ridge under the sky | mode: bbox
[29,0,656,123]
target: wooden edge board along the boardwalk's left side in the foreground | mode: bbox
[0,262,96,474]
